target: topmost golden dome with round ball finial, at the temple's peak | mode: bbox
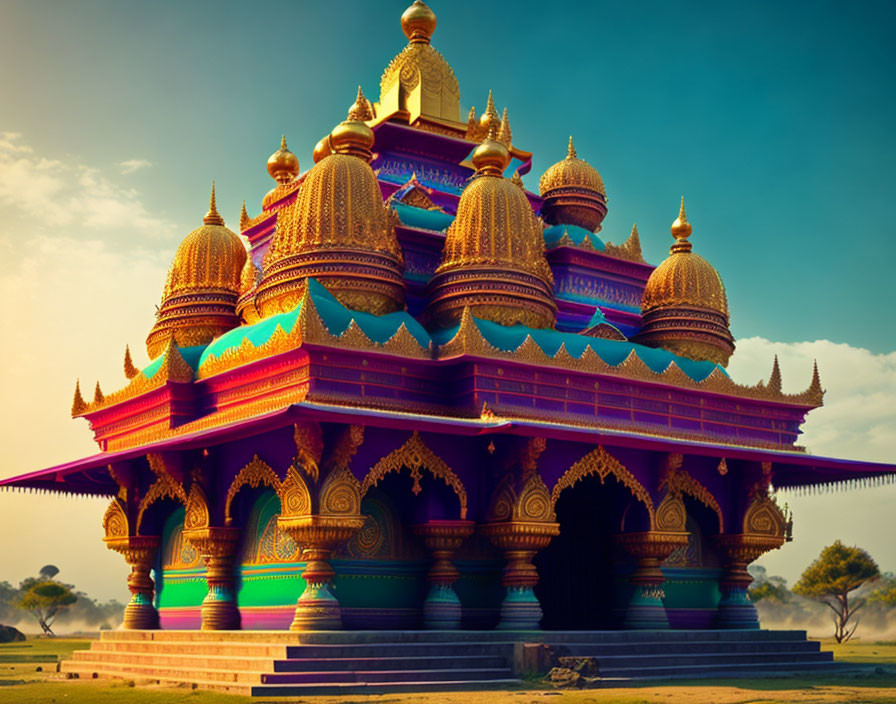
[377,0,460,122]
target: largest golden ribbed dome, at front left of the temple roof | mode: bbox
[255,102,404,317]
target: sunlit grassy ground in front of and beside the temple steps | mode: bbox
[0,638,896,704]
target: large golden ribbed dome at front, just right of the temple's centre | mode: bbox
[429,127,556,327]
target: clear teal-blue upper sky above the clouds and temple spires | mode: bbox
[0,0,896,351]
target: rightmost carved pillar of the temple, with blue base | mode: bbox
[716,533,768,629]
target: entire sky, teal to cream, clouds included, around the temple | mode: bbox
[0,0,896,598]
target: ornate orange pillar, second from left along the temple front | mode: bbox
[184,526,240,631]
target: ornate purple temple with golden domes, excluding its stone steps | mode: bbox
[2,0,896,631]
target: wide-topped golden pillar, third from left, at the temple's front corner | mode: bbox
[277,515,364,631]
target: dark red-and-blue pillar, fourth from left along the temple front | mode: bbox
[414,521,473,630]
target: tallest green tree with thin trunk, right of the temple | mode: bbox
[793,540,880,643]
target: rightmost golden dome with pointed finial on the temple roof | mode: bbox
[634,198,734,365]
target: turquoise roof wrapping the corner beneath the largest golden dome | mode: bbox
[199,279,430,366]
